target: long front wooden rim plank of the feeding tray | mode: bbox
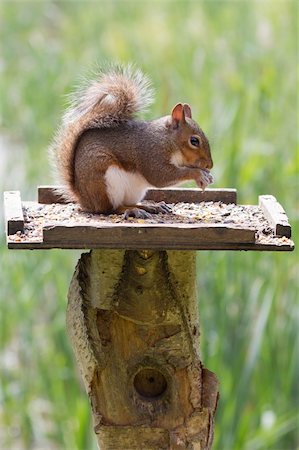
[43,223,255,249]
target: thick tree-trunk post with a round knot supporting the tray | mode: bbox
[67,250,218,450]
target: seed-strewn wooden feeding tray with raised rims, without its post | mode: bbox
[4,186,294,251]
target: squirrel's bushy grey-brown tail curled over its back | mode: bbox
[50,65,153,201]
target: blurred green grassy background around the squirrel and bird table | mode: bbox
[0,0,299,450]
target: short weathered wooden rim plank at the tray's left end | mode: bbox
[4,191,24,236]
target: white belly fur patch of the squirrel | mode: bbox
[105,166,151,209]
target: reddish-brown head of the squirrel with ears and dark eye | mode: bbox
[167,103,213,169]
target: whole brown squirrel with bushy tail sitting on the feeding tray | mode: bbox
[50,66,213,218]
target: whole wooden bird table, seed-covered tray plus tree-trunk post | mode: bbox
[4,186,294,450]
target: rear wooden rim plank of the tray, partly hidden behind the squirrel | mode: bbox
[38,186,237,204]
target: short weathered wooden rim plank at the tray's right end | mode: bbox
[259,195,291,238]
